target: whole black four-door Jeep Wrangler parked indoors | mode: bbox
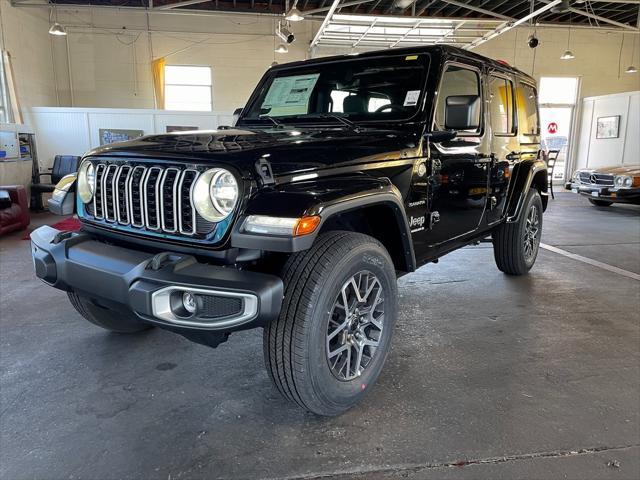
[31,46,547,415]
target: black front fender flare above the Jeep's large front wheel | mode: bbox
[231,175,416,272]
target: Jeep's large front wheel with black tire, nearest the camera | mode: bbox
[263,232,397,415]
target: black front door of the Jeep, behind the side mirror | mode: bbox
[425,63,491,248]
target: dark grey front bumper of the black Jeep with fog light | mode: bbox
[31,226,283,344]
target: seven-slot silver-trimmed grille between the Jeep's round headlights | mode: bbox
[87,163,208,236]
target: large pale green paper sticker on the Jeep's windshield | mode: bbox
[262,73,320,115]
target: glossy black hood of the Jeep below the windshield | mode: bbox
[87,128,419,176]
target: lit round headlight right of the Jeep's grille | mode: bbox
[193,168,239,222]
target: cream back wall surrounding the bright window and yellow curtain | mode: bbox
[47,9,314,111]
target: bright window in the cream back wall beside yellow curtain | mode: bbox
[164,65,213,111]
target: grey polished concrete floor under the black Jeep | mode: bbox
[0,193,640,480]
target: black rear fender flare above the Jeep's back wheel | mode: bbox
[505,159,549,223]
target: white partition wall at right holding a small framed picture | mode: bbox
[576,91,640,168]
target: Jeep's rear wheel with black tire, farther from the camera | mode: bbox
[492,188,542,275]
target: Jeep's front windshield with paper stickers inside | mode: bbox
[239,55,428,125]
